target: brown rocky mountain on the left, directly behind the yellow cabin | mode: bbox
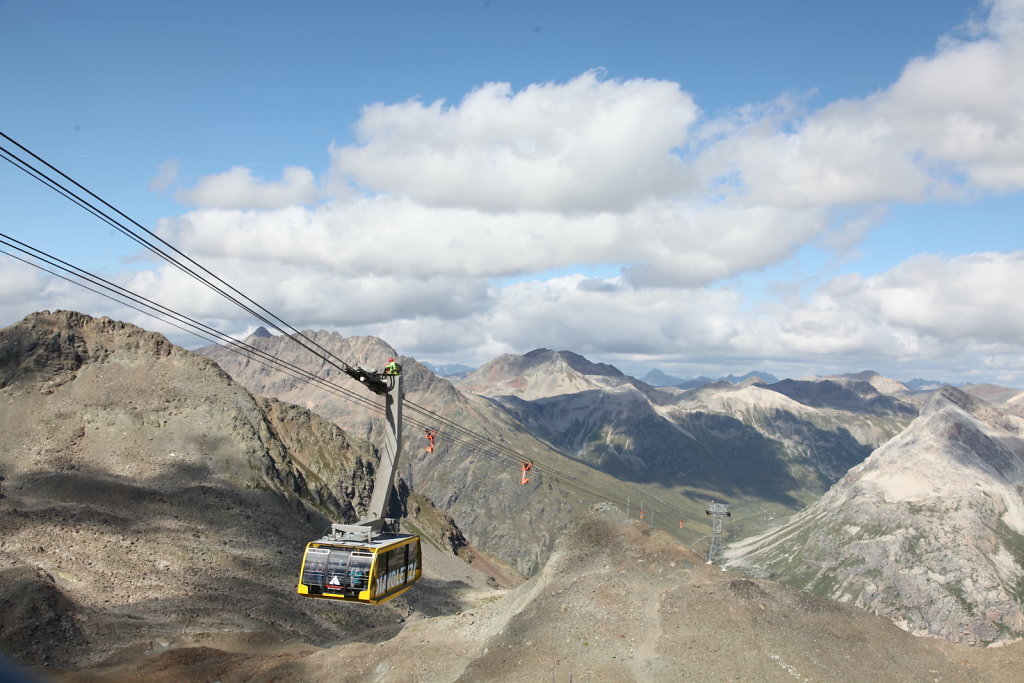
[0,311,393,664]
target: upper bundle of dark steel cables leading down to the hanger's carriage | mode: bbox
[0,131,353,382]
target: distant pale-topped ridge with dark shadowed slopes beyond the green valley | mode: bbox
[468,351,918,528]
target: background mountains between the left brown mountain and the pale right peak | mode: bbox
[197,339,916,557]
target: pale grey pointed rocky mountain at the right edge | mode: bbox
[727,387,1024,644]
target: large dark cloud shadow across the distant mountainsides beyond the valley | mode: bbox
[492,385,872,508]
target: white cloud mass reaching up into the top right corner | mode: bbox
[697,1,1024,206]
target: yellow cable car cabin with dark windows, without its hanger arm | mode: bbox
[298,533,423,605]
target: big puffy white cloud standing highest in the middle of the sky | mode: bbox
[332,72,699,212]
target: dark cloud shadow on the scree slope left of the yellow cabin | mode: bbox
[0,465,415,664]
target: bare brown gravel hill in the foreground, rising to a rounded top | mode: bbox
[37,508,1024,683]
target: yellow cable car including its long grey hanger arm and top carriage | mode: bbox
[297,365,423,605]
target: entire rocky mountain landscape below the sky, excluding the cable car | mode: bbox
[0,311,1024,680]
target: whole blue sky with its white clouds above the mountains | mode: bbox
[0,0,1024,388]
